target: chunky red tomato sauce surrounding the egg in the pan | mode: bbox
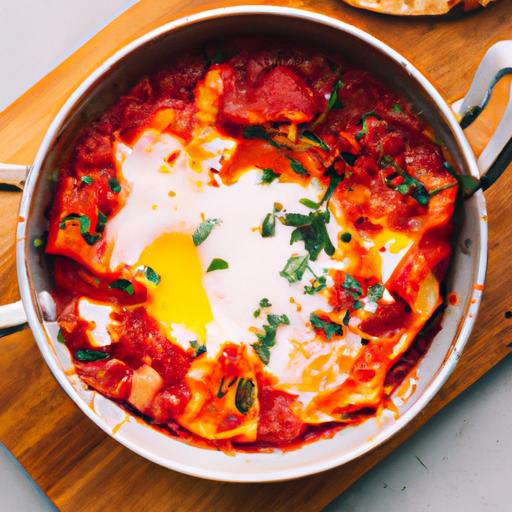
[46,39,457,450]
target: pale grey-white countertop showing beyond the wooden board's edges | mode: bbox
[0,0,512,512]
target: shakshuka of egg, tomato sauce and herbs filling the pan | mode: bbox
[45,38,458,451]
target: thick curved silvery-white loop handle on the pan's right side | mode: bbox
[452,40,512,190]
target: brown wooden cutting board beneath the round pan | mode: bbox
[0,0,512,512]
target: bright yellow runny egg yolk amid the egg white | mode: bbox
[137,233,213,340]
